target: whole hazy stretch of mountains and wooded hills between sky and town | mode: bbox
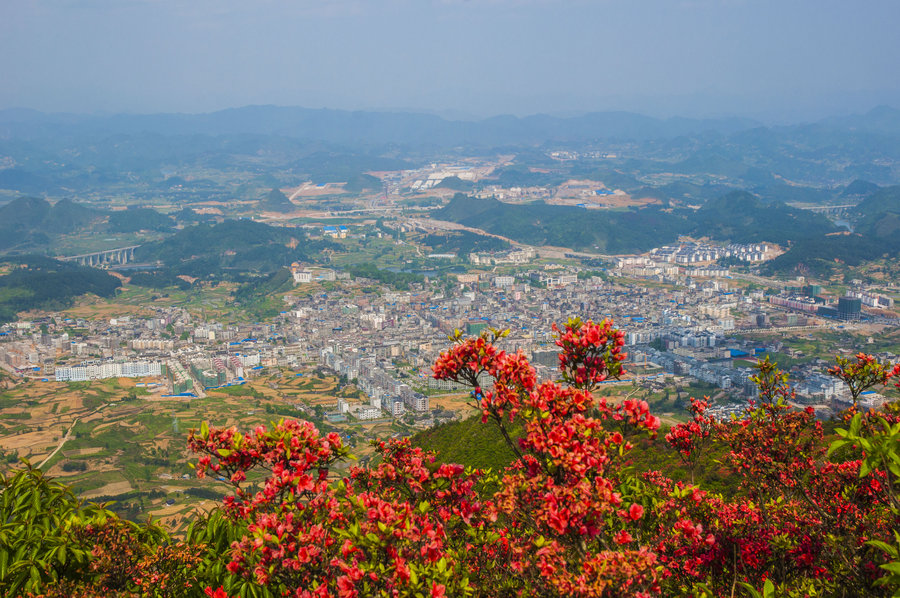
[0,106,900,288]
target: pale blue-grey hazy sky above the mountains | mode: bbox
[0,0,900,119]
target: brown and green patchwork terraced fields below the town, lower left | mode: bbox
[0,368,409,526]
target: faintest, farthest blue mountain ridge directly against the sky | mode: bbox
[0,106,761,146]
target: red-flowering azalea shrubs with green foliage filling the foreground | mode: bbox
[0,319,900,598]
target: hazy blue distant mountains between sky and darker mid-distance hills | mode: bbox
[0,106,900,205]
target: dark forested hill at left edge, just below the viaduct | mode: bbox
[0,256,120,323]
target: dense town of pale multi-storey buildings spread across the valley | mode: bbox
[0,247,896,425]
